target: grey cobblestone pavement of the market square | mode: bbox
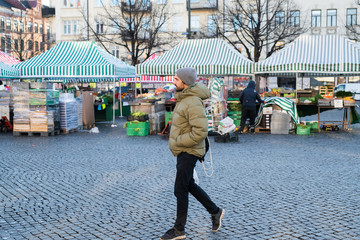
[0,117,360,240]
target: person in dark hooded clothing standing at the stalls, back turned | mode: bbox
[239,80,264,133]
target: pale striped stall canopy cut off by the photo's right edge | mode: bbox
[255,35,360,76]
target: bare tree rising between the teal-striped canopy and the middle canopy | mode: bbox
[79,0,174,65]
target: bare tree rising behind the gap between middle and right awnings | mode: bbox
[215,0,307,62]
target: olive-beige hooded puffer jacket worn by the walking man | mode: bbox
[169,83,210,157]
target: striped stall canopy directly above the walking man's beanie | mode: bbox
[136,39,253,76]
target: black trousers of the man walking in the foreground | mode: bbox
[174,152,219,231]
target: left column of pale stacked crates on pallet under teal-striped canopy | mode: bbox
[12,82,30,133]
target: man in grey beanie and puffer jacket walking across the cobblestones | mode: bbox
[160,68,225,240]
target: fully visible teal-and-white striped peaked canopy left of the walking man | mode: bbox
[14,42,135,82]
